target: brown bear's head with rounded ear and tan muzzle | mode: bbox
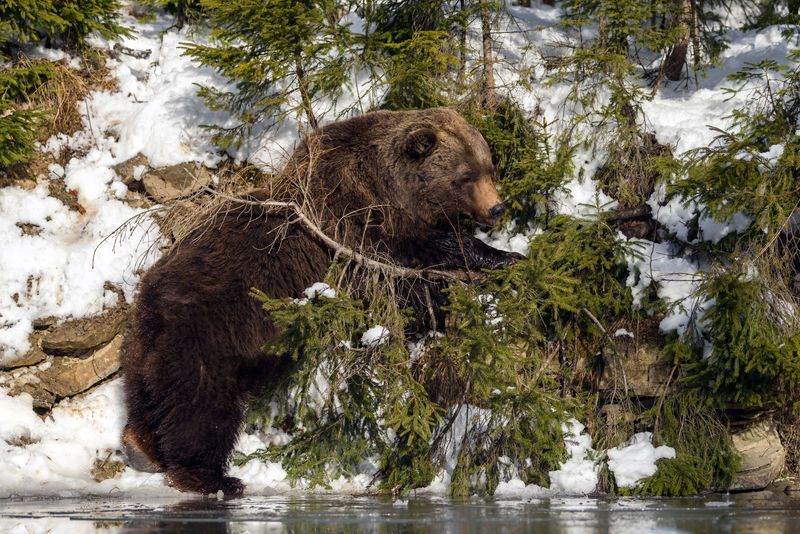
[394,108,505,230]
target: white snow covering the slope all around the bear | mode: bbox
[0,2,789,498]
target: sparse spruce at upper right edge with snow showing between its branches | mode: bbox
[670,51,800,245]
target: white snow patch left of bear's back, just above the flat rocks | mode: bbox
[0,185,161,362]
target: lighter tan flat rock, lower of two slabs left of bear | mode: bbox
[39,334,122,397]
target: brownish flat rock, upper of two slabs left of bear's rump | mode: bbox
[42,307,128,354]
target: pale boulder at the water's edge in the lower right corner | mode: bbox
[730,419,786,491]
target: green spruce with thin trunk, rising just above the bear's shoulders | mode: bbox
[187,0,358,146]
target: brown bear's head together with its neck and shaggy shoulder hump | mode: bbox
[284,108,505,239]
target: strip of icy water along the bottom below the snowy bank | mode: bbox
[0,492,800,534]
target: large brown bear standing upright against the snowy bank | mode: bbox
[117,109,520,495]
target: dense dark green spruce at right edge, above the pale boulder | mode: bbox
[671,268,800,408]
